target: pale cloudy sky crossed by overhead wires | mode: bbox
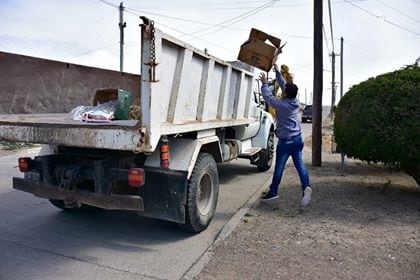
[0,0,420,105]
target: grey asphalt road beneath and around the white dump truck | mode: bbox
[0,110,324,280]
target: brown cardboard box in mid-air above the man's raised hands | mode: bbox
[238,28,282,72]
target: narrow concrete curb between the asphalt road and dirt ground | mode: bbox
[181,176,271,280]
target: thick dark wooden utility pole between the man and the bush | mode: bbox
[312,0,323,166]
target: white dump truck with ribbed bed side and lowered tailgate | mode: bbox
[0,19,275,233]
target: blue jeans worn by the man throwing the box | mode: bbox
[270,135,309,195]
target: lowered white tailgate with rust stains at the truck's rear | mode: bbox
[0,114,141,150]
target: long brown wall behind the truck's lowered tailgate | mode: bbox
[0,52,140,114]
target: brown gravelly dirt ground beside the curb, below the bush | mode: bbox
[195,132,420,279]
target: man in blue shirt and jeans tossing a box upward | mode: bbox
[260,64,312,205]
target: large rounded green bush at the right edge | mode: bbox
[334,64,420,185]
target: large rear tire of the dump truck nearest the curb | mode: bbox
[182,153,219,233]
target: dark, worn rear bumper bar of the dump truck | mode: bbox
[13,177,144,211]
